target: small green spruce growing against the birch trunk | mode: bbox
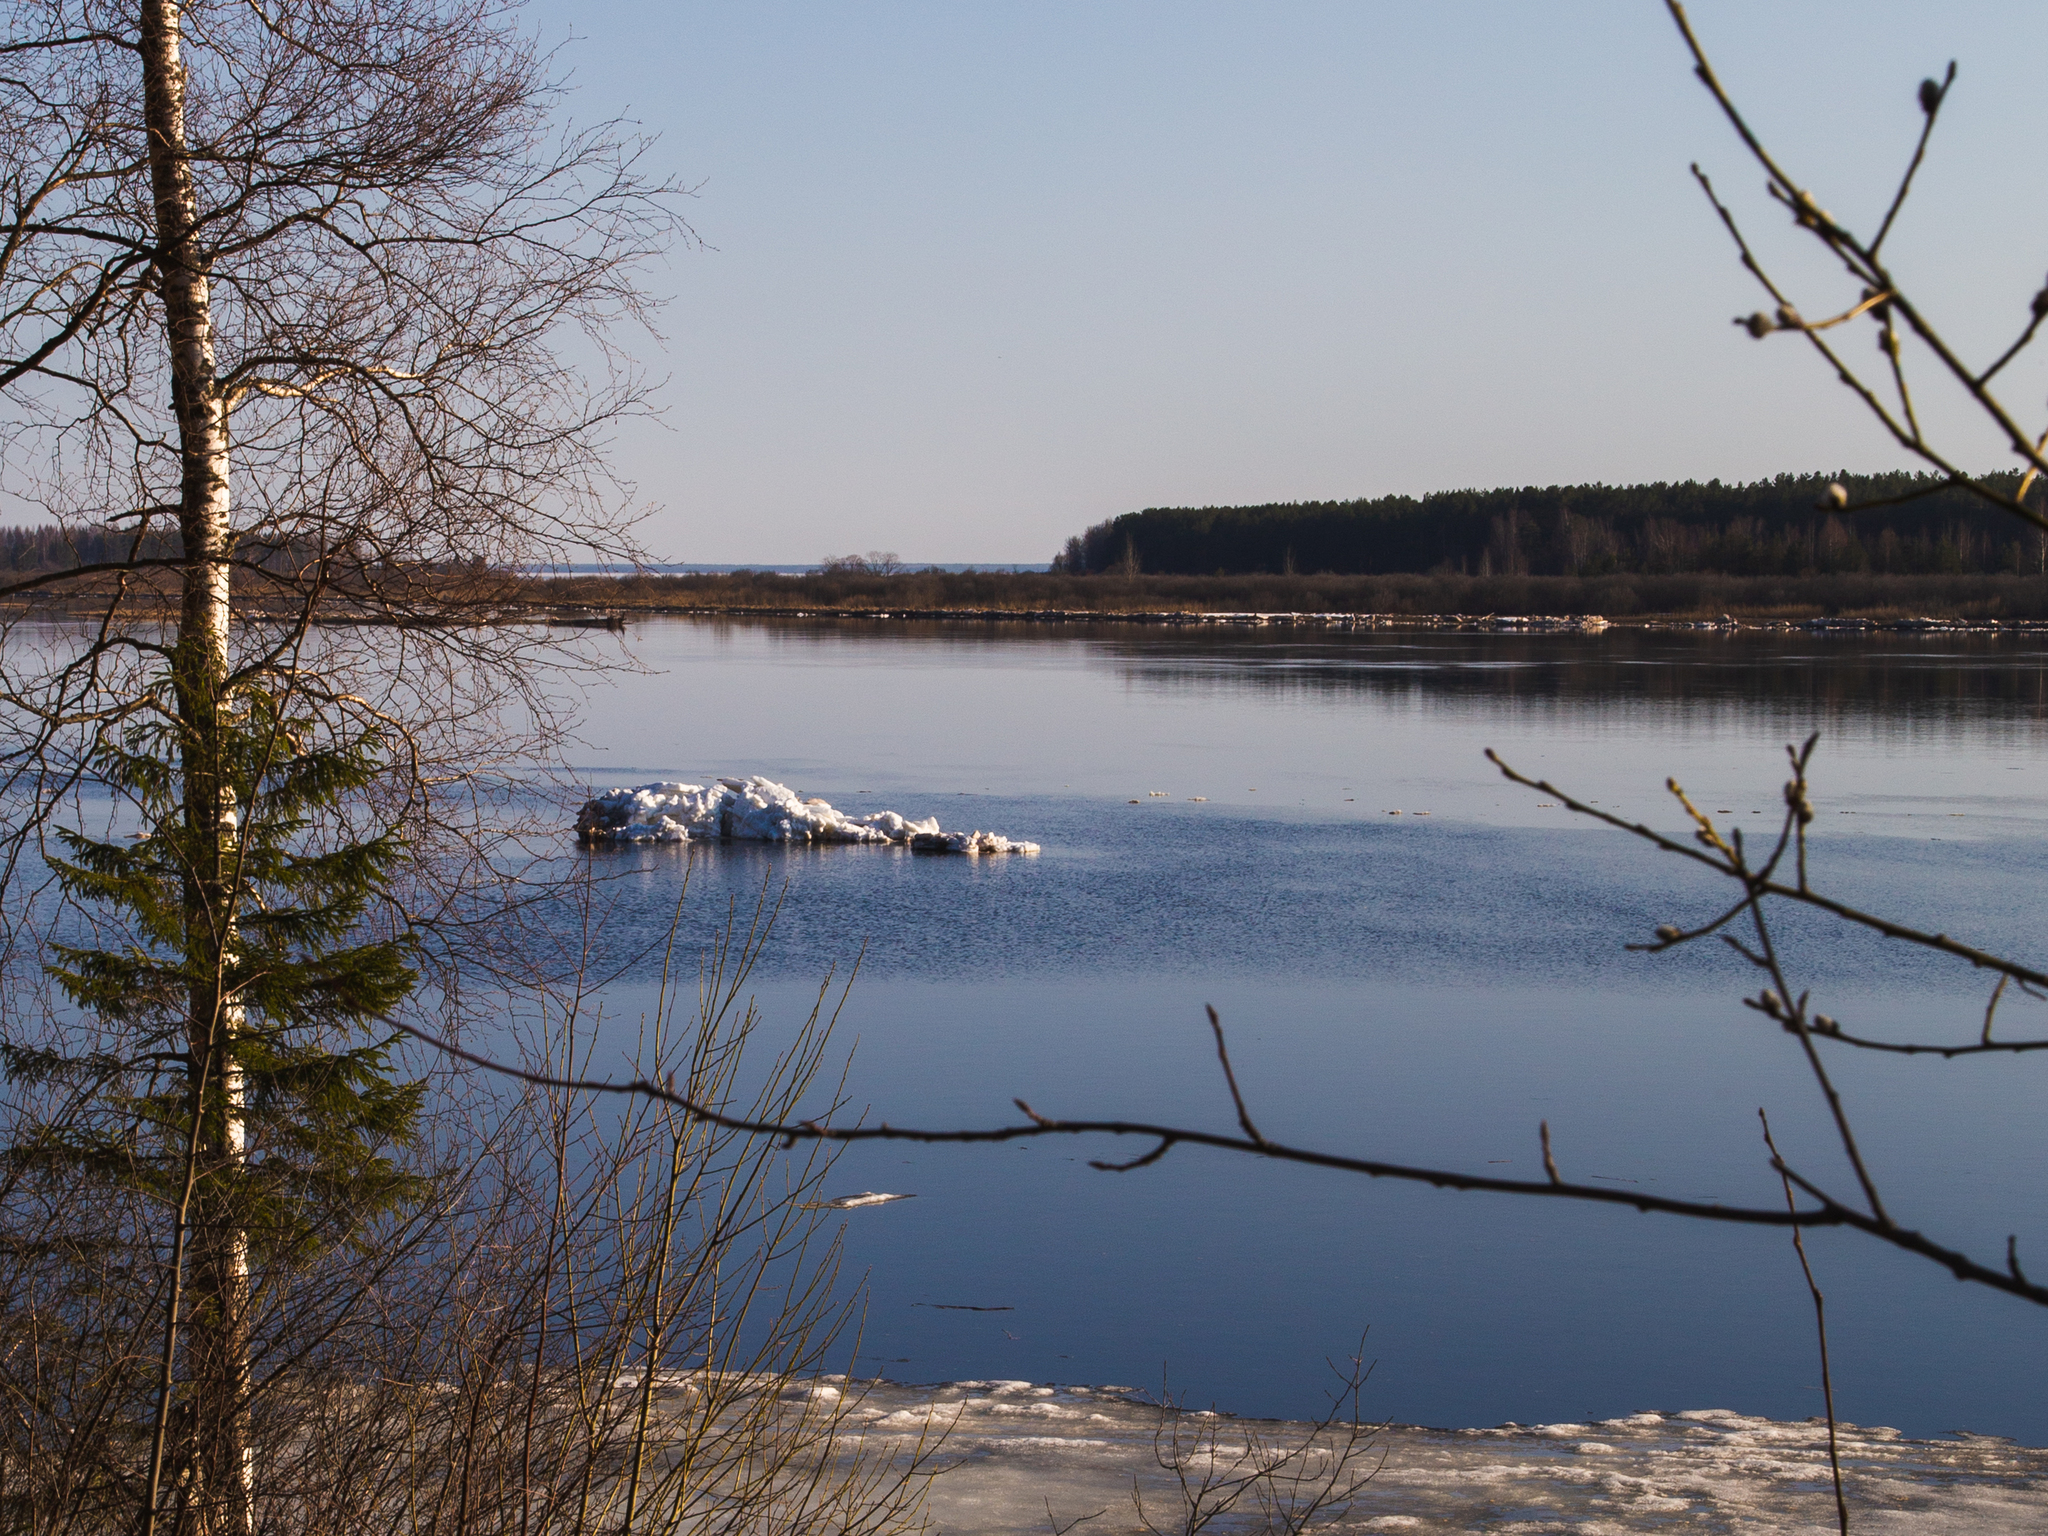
[4,690,424,1530]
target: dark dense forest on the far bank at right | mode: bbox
[1053,473,2048,575]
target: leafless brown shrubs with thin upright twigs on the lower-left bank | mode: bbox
[0,876,938,1536]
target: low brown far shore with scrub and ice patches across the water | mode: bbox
[16,567,2048,633]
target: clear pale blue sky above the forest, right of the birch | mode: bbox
[530,0,2048,563]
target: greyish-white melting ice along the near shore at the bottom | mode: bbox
[799,1376,2048,1536]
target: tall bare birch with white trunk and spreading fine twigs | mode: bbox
[0,0,688,1532]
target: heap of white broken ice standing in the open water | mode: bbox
[575,774,1038,854]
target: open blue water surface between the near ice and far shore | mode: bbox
[575,621,2048,1444]
